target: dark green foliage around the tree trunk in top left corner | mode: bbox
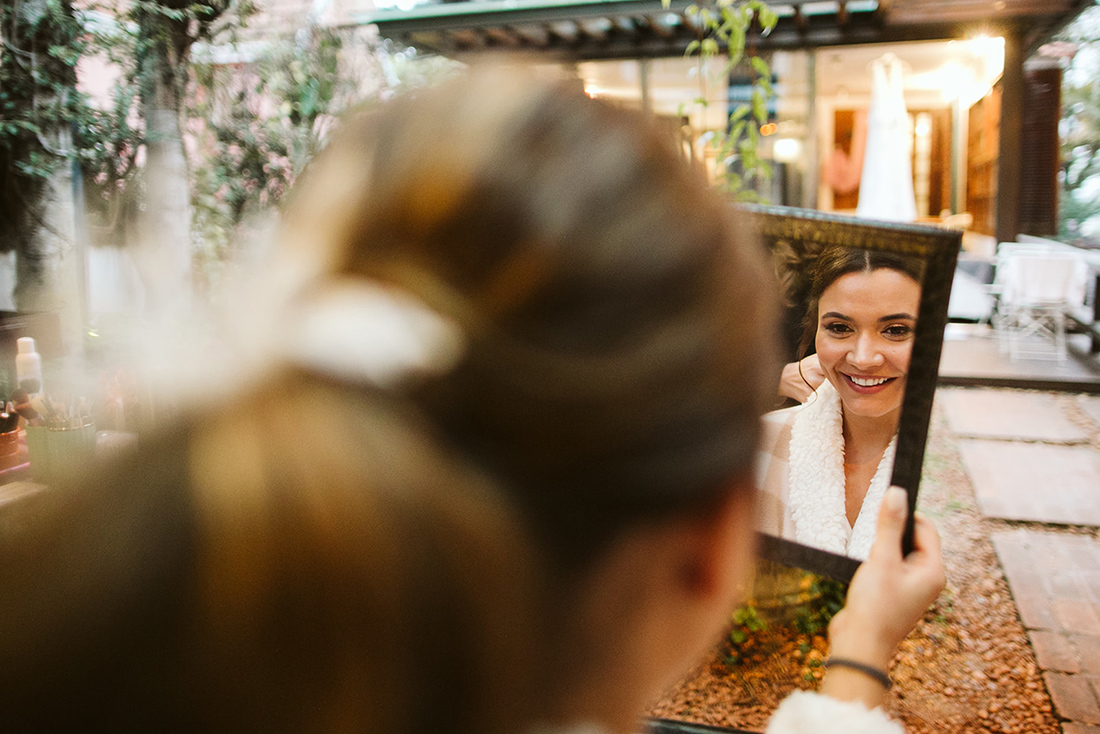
[0,0,234,250]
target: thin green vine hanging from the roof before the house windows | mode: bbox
[666,0,779,201]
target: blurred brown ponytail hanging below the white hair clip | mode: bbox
[0,372,542,734]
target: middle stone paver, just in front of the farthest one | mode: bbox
[958,439,1100,525]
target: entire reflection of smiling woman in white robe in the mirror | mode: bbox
[757,247,923,560]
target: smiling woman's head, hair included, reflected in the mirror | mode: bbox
[806,248,922,420]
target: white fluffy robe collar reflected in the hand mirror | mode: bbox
[788,381,898,560]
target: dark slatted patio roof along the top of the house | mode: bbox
[367,0,1092,61]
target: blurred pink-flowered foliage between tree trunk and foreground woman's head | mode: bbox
[187,34,458,290]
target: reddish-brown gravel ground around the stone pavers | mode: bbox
[651,396,1073,734]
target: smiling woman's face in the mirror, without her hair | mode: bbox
[815,267,921,418]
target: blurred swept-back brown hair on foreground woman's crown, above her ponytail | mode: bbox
[279,69,773,566]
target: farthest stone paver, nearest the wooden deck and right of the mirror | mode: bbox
[936,390,1088,443]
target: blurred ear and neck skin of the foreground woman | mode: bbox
[547,479,756,731]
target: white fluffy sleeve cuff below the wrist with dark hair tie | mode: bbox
[766,691,905,734]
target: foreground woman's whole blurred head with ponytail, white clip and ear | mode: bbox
[0,69,776,732]
